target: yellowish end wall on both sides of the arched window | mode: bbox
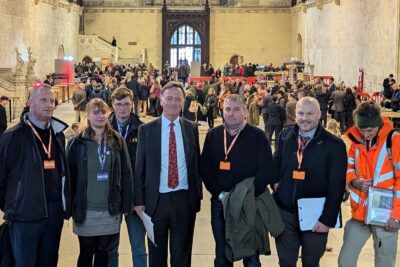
[84,7,292,68]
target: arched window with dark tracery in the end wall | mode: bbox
[170,25,201,67]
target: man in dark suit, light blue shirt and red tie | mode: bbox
[134,82,202,267]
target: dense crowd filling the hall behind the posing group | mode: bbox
[72,62,372,147]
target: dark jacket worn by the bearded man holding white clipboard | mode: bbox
[274,125,347,227]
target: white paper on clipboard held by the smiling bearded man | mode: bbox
[297,197,340,231]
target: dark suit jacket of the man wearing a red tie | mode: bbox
[134,117,203,216]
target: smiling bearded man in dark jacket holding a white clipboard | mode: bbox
[274,97,347,267]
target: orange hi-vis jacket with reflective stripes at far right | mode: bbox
[346,118,400,221]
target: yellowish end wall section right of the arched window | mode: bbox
[210,8,292,68]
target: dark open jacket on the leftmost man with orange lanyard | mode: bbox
[0,113,71,222]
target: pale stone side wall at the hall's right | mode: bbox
[291,0,399,91]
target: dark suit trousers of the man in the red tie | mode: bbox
[148,190,196,267]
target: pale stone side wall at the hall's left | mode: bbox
[0,0,80,78]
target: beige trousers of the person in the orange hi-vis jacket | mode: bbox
[339,219,398,267]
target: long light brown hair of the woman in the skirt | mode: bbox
[85,98,122,150]
